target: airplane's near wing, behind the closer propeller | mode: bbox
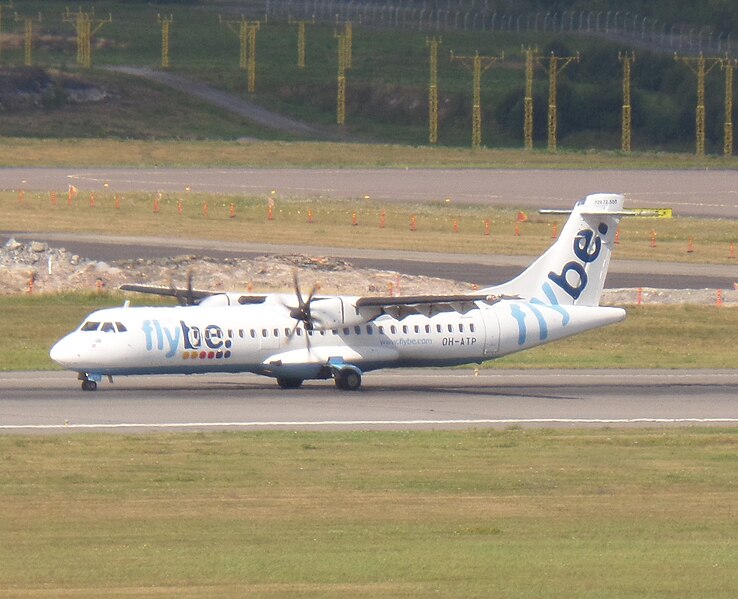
[356,294,512,320]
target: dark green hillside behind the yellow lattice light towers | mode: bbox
[0,1,730,153]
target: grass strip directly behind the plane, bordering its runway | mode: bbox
[0,294,738,370]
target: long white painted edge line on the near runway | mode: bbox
[0,418,738,430]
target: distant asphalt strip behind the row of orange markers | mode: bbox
[0,168,738,218]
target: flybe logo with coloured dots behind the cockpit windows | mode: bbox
[141,319,231,360]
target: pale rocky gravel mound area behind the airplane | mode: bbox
[0,239,738,305]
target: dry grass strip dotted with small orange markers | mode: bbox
[5,191,738,264]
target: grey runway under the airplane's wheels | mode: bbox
[0,369,738,434]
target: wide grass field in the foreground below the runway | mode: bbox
[0,429,738,599]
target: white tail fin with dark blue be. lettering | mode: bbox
[482,193,623,306]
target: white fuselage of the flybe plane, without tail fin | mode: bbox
[51,298,625,378]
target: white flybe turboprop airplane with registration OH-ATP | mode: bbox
[50,193,629,391]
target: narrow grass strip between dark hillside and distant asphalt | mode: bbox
[0,137,738,170]
